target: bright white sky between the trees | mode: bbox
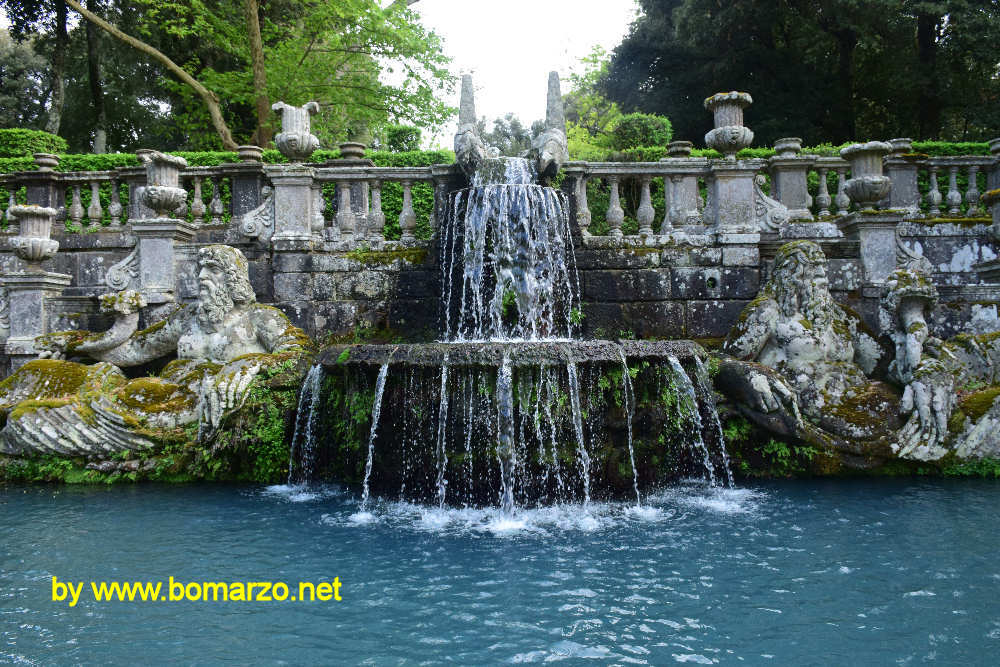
[411,0,638,146]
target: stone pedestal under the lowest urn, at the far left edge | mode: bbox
[0,271,72,372]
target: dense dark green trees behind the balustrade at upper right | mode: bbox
[601,0,1000,144]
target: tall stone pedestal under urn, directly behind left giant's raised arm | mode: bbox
[132,218,195,306]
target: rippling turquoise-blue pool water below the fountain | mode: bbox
[0,480,1000,665]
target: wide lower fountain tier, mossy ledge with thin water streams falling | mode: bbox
[292,340,728,507]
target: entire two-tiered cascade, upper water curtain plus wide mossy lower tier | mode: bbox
[290,158,732,522]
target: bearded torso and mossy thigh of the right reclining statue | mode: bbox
[717,241,899,465]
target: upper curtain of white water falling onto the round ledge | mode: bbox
[441,158,579,340]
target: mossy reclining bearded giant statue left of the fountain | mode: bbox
[0,245,309,458]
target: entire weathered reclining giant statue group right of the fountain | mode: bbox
[716,241,1000,467]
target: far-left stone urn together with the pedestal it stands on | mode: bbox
[0,205,72,371]
